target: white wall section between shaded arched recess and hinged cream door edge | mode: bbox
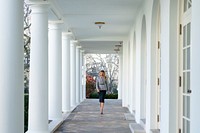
[146,0,160,130]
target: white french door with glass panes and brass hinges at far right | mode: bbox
[179,0,192,133]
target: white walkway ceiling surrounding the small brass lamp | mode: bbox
[49,0,144,54]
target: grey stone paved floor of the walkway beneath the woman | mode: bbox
[54,99,133,133]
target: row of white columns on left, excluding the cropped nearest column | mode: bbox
[28,4,84,133]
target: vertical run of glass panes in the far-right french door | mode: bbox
[182,22,191,133]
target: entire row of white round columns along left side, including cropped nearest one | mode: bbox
[0,0,85,133]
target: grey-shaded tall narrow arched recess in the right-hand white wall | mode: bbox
[140,16,147,124]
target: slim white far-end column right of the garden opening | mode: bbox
[118,53,123,99]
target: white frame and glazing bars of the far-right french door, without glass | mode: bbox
[178,0,191,133]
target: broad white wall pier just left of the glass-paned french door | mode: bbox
[161,0,178,133]
